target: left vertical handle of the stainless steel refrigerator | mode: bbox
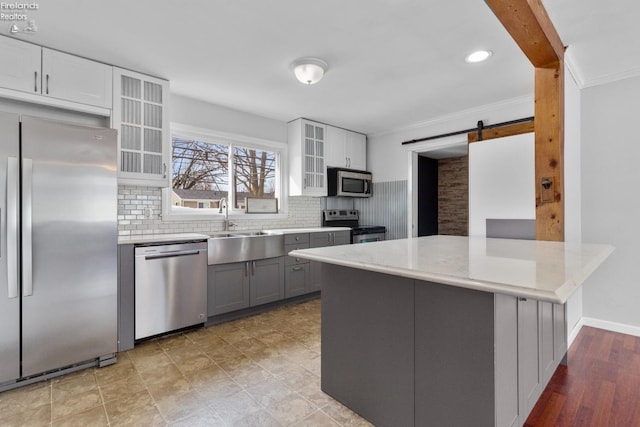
[6,157,18,298]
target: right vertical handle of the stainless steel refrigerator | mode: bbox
[22,157,33,297]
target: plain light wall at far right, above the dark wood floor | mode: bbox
[581,77,640,335]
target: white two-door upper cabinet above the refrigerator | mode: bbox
[0,37,112,109]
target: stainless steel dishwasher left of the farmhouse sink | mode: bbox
[135,242,207,340]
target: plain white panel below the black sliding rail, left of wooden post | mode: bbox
[469,133,536,237]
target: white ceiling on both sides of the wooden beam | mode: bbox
[5,0,640,134]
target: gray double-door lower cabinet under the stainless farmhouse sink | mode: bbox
[207,257,284,317]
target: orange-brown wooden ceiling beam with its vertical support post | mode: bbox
[485,0,564,241]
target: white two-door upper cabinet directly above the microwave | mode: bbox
[327,126,367,170]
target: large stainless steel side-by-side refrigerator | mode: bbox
[0,112,117,390]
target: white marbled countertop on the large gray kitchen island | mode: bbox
[290,236,614,304]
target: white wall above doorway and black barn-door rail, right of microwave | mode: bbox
[367,96,533,182]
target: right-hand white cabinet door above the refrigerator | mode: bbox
[42,48,113,108]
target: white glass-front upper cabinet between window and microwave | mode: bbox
[288,119,327,196]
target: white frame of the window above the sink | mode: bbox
[162,123,289,221]
